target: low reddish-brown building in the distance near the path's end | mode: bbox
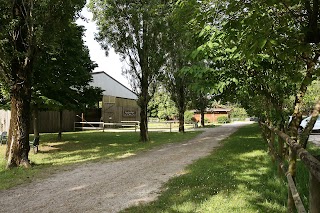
[194,108,231,123]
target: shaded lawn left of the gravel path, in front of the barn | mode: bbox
[0,131,200,189]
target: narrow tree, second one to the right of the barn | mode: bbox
[162,0,200,132]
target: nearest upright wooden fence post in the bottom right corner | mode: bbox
[309,156,320,213]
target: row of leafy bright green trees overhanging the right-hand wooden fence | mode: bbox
[190,0,320,212]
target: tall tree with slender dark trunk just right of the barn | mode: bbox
[90,0,165,142]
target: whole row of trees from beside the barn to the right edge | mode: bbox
[91,0,320,208]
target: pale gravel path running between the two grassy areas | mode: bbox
[0,124,250,213]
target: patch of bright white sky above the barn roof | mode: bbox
[77,4,131,89]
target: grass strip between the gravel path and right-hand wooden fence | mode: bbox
[123,125,287,213]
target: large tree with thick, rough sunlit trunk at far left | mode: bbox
[0,0,85,168]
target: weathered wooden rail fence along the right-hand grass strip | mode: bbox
[260,123,320,213]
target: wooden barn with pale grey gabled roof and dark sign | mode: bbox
[90,71,140,123]
